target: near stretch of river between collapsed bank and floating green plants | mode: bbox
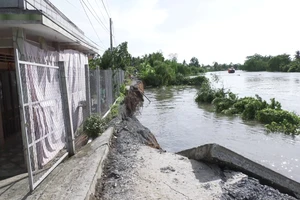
[138,82,300,182]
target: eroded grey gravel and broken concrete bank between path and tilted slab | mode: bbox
[91,83,295,200]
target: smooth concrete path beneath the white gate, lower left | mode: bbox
[0,128,114,200]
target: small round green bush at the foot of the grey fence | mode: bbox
[83,115,106,139]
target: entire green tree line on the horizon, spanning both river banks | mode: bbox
[90,42,300,86]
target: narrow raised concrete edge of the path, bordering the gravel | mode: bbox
[84,127,114,200]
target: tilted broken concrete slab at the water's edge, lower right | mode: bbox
[177,144,300,198]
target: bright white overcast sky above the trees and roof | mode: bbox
[50,0,300,65]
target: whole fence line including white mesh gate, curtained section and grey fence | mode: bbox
[16,45,124,190]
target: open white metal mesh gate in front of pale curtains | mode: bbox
[15,50,68,191]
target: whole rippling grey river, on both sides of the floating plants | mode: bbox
[138,71,300,182]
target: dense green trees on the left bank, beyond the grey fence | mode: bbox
[89,42,241,86]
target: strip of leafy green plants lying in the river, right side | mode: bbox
[196,81,300,135]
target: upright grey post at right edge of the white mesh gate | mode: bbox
[58,61,75,156]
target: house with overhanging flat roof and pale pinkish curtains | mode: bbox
[0,0,98,190]
